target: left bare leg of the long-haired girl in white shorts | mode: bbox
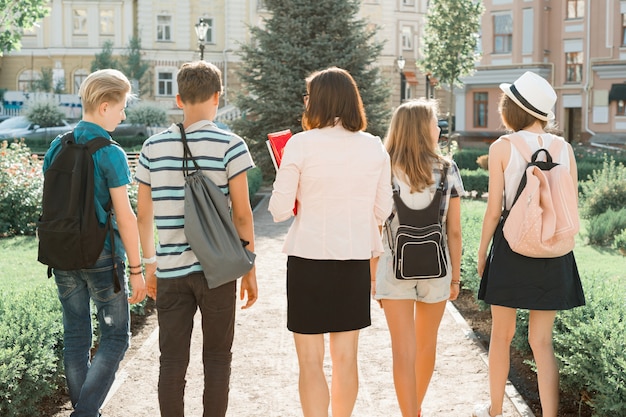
[382,300,419,417]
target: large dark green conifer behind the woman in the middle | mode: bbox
[233,0,389,177]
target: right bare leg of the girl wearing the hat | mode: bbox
[528,310,559,417]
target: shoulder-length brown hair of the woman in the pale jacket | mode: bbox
[302,67,367,132]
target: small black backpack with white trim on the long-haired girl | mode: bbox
[385,164,448,280]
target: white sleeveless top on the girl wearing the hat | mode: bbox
[498,130,569,209]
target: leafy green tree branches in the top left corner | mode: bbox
[0,0,50,56]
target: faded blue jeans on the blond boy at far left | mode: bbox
[54,252,130,417]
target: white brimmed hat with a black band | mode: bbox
[500,71,556,121]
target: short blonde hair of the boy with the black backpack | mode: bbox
[78,69,132,113]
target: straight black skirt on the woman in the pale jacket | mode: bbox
[287,256,371,334]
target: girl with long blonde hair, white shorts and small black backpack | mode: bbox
[375,99,464,417]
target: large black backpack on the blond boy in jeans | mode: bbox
[37,132,120,292]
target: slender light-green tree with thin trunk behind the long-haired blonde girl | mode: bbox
[417,0,484,152]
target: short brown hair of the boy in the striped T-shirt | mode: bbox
[176,61,222,104]
